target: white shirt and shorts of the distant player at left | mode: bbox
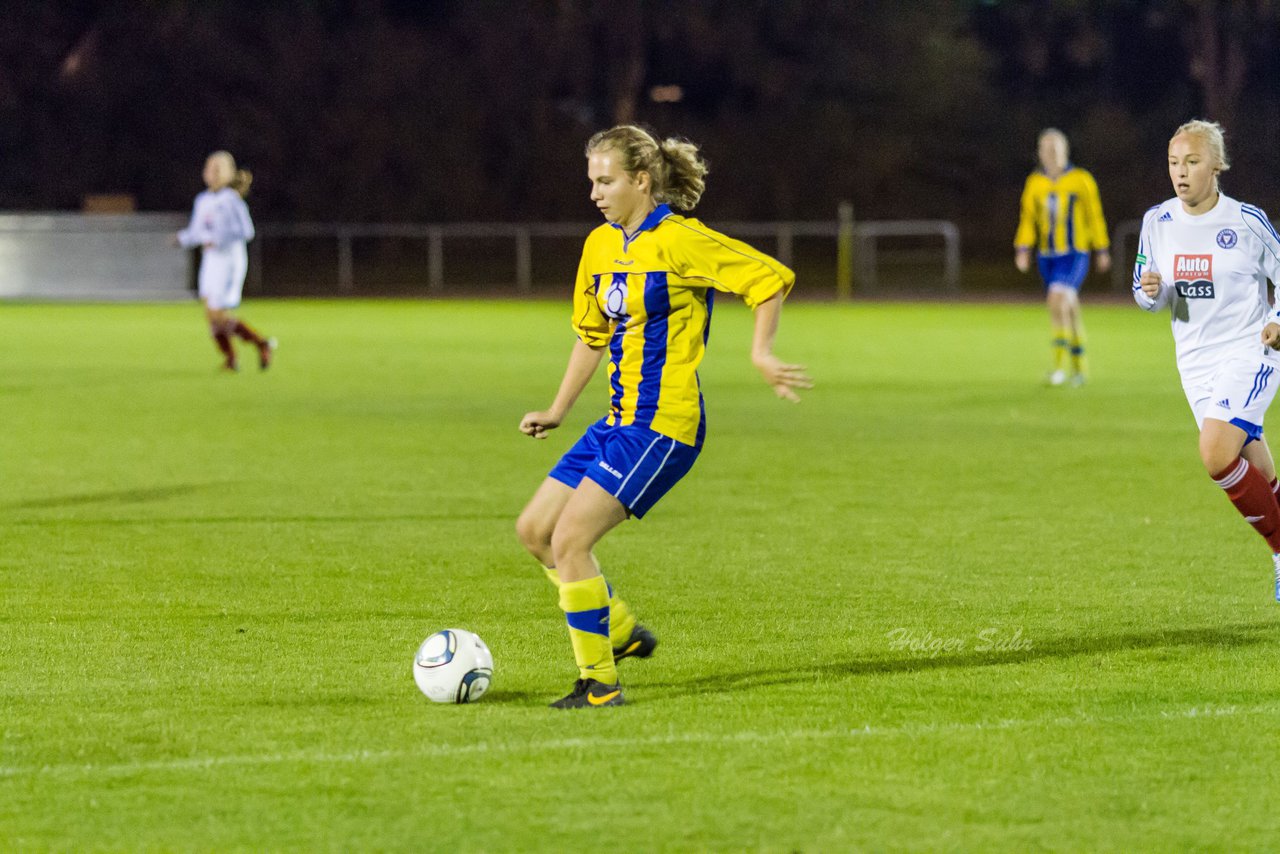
[178,187,253,309]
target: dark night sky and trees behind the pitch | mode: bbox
[0,0,1280,263]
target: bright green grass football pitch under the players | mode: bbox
[0,300,1280,851]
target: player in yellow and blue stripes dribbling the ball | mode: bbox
[516,125,812,708]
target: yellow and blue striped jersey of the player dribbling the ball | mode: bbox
[573,205,795,447]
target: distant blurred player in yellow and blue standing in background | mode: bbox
[1014,128,1111,385]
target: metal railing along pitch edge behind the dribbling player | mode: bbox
[250,212,960,297]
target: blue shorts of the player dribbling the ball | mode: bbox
[548,419,700,519]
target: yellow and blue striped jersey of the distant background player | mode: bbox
[1014,165,1111,256]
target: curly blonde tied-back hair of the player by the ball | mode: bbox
[586,124,709,210]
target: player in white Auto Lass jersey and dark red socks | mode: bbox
[1133,120,1280,600]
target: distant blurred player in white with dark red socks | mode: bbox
[177,151,275,371]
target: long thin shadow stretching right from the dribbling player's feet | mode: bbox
[645,621,1280,694]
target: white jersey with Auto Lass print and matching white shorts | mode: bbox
[1133,195,1280,438]
